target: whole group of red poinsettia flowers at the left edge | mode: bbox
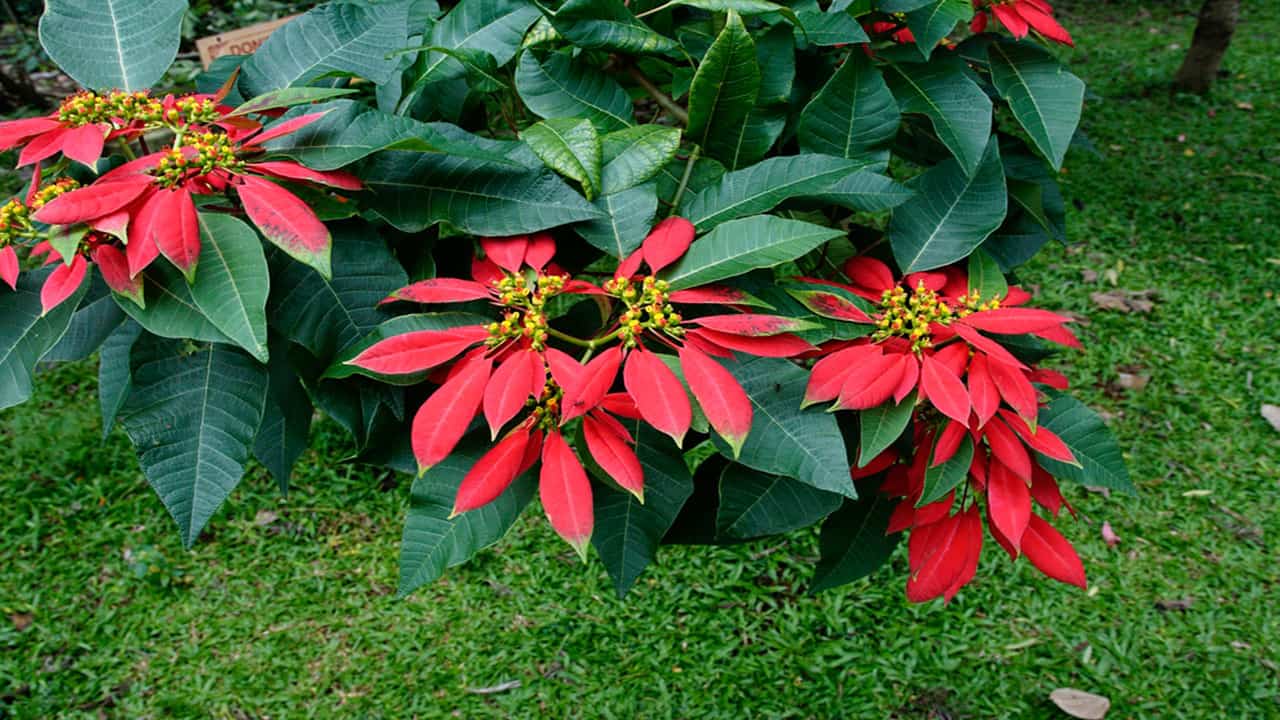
[0,92,361,313]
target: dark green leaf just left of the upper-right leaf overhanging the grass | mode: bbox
[884,54,992,174]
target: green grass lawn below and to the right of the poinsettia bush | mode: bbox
[0,3,1280,719]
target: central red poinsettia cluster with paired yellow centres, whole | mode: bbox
[349,218,814,552]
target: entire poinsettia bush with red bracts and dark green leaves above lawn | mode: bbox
[0,0,1132,601]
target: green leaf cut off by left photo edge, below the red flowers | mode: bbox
[0,268,90,410]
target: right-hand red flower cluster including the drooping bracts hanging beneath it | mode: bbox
[795,258,1084,601]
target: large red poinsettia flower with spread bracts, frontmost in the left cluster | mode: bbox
[35,113,361,279]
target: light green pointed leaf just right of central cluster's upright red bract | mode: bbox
[664,215,844,290]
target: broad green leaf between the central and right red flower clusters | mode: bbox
[712,355,856,497]
